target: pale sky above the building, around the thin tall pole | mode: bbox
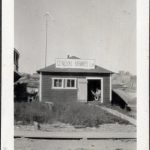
[14,0,136,74]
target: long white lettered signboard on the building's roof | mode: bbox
[56,58,95,69]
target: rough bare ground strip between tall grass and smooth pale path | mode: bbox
[15,122,136,132]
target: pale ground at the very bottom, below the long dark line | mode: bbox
[15,138,136,150]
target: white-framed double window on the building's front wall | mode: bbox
[52,78,76,89]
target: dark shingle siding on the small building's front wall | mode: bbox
[42,74,110,103]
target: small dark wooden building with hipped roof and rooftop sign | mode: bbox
[37,57,113,103]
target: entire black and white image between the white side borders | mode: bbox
[2,0,148,150]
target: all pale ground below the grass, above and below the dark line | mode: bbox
[14,122,136,150]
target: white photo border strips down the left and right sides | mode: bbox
[1,0,149,150]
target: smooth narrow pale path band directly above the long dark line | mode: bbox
[15,131,136,139]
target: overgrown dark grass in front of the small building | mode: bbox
[14,101,129,127]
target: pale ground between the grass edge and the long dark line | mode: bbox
[14,123,136,139]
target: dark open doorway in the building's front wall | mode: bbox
[87,79,102,101]
